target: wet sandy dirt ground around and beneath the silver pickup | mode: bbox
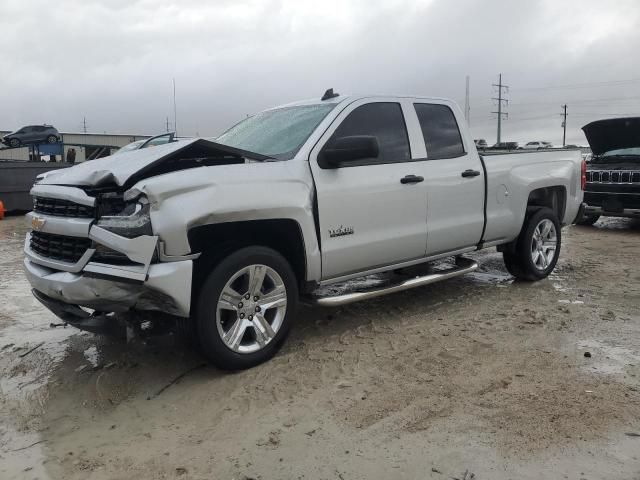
[0,217,640,480]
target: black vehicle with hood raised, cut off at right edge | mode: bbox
[576,117,640,225]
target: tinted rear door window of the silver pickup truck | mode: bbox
[414,103,465,160]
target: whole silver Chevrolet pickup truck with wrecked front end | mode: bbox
[24,90,585,369]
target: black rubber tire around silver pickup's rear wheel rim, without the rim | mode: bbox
[502,208,562,282]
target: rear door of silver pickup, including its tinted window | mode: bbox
[414,102,485,256]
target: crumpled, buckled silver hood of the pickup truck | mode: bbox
[39,138,269,187]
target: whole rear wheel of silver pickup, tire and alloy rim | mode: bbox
[502,208,562,282]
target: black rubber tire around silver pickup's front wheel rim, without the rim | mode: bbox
[195,246,298,370]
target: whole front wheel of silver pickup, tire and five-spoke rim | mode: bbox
[196,246,298,370]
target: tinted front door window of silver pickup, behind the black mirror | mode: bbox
[327,102,411,165]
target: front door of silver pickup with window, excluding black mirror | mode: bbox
[310,99,427,279]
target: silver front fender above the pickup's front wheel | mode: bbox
[135,160,320,280]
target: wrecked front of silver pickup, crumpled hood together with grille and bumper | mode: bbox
[24,140,263,331]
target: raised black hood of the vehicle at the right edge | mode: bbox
[582,117,640,155]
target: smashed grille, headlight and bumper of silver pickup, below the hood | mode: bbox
[24,185,193,323]
